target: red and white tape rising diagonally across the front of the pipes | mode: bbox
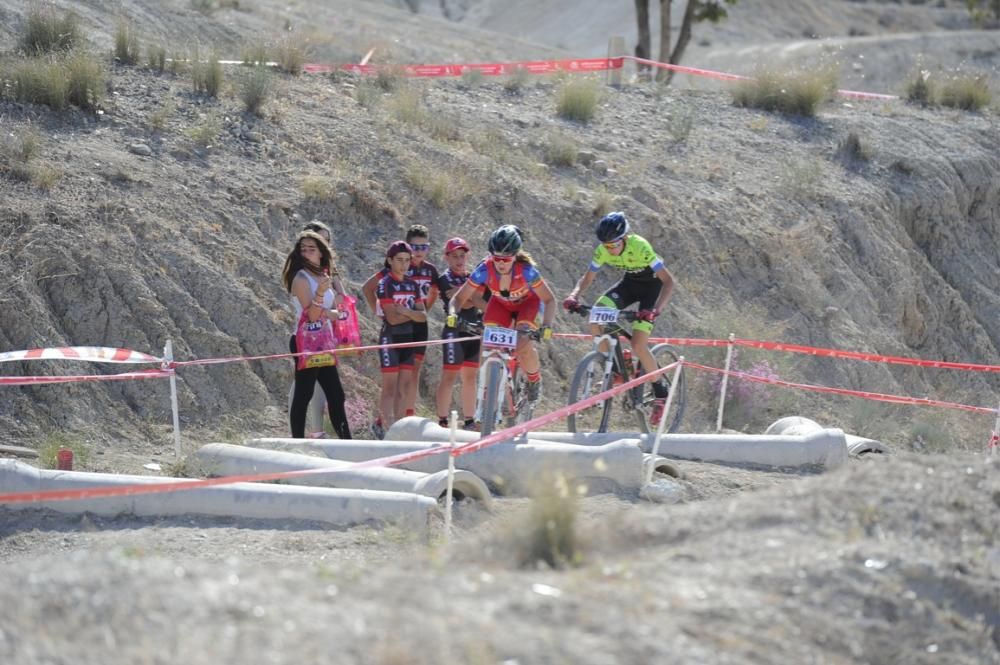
[0,363,677,504]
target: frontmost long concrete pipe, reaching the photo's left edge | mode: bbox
[0,460,440,534]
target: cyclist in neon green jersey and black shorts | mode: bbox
[563,212,674,422]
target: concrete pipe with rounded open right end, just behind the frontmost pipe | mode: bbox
[195,443,493,509]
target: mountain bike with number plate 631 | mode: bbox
[476,326,541,436]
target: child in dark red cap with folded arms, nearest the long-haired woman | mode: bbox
[373,240,427,438]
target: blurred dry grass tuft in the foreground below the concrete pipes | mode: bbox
[517,475,583,568]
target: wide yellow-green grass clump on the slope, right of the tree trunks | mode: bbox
[733,67,837,117]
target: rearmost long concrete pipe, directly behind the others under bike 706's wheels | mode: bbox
[386,417,847,468]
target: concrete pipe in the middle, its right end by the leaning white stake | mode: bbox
[247,439,643,495]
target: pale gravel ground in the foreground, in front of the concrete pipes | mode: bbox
[0,454,1000,665]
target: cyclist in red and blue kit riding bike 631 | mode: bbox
[448,225,555,406]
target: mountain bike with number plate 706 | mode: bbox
[567,305,685,432]
